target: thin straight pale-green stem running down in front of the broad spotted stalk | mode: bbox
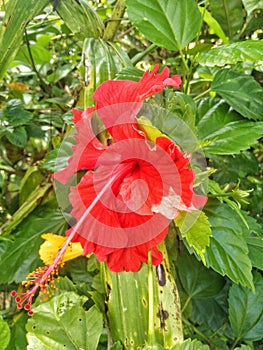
[148,251,155,346]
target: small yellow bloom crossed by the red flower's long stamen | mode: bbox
[39,233,83,265]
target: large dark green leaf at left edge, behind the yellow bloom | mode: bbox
[0,202,67,283]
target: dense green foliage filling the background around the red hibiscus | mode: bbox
[0,0,263,350]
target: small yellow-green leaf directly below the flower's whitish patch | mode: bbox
[174,210,212,262]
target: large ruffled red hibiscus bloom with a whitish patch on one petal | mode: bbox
[54,66,206,272]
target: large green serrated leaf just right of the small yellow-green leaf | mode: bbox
[205,201,253,289]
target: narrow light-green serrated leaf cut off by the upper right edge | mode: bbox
[197,40,263,67]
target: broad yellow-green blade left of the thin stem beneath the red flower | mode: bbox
[101,264,148,350]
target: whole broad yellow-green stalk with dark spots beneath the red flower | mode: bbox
[102,243,183,350]
